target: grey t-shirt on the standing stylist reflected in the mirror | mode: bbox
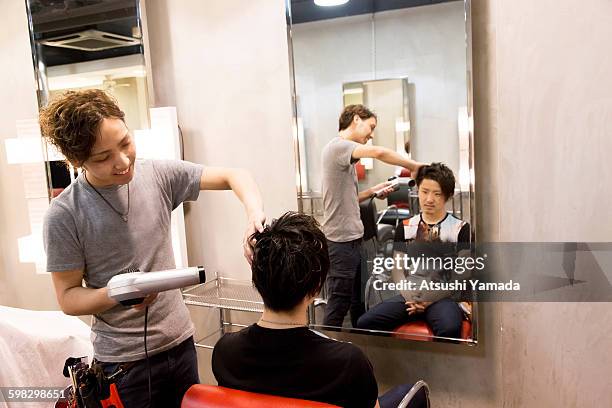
[321,137,363,242]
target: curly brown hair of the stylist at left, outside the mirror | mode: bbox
[39,89,125,166]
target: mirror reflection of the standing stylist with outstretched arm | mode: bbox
[321,105,422,327]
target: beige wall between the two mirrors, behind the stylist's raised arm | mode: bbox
[147,0,297,279]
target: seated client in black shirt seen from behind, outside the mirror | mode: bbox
[212,212,424,408]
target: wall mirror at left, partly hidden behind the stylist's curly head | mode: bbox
[26,0,149,198]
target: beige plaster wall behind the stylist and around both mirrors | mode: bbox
[0,0,612,408]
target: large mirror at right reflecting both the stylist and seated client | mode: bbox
[288,0,477,343]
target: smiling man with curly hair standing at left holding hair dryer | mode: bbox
[40,90,265,408]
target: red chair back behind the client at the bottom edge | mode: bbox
[181,384,338,408]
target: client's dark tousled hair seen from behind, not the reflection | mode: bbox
[251,212,329,312]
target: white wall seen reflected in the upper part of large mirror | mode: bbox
[292,1,466,190]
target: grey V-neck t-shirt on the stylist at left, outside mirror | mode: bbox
[43,160,203,362]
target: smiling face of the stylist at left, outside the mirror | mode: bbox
[83,118,136,187]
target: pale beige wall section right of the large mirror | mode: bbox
[490,0,612,407]
